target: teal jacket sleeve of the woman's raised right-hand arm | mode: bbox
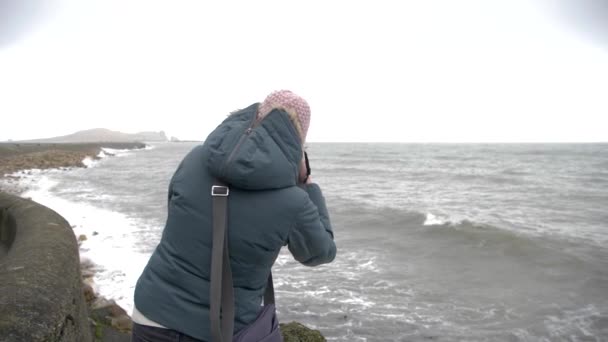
[287,184,336,266]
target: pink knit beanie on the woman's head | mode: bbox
[258,90,310,142]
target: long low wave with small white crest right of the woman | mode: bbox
[332,200,595,268]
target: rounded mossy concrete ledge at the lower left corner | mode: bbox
[0,192,91,342]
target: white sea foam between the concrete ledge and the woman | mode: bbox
[23,174,149,312]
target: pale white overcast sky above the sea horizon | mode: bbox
[0,0,608,142]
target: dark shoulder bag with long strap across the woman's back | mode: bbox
[209,180,283,342]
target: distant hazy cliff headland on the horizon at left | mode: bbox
[28,128,169,143]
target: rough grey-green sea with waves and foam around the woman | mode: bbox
[2,143,608,342]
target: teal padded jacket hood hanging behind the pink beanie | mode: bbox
[205,103,302,190]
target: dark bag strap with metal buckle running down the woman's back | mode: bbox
[209,179,274,342]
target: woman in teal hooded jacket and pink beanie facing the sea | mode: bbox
[133,90,336,341]
